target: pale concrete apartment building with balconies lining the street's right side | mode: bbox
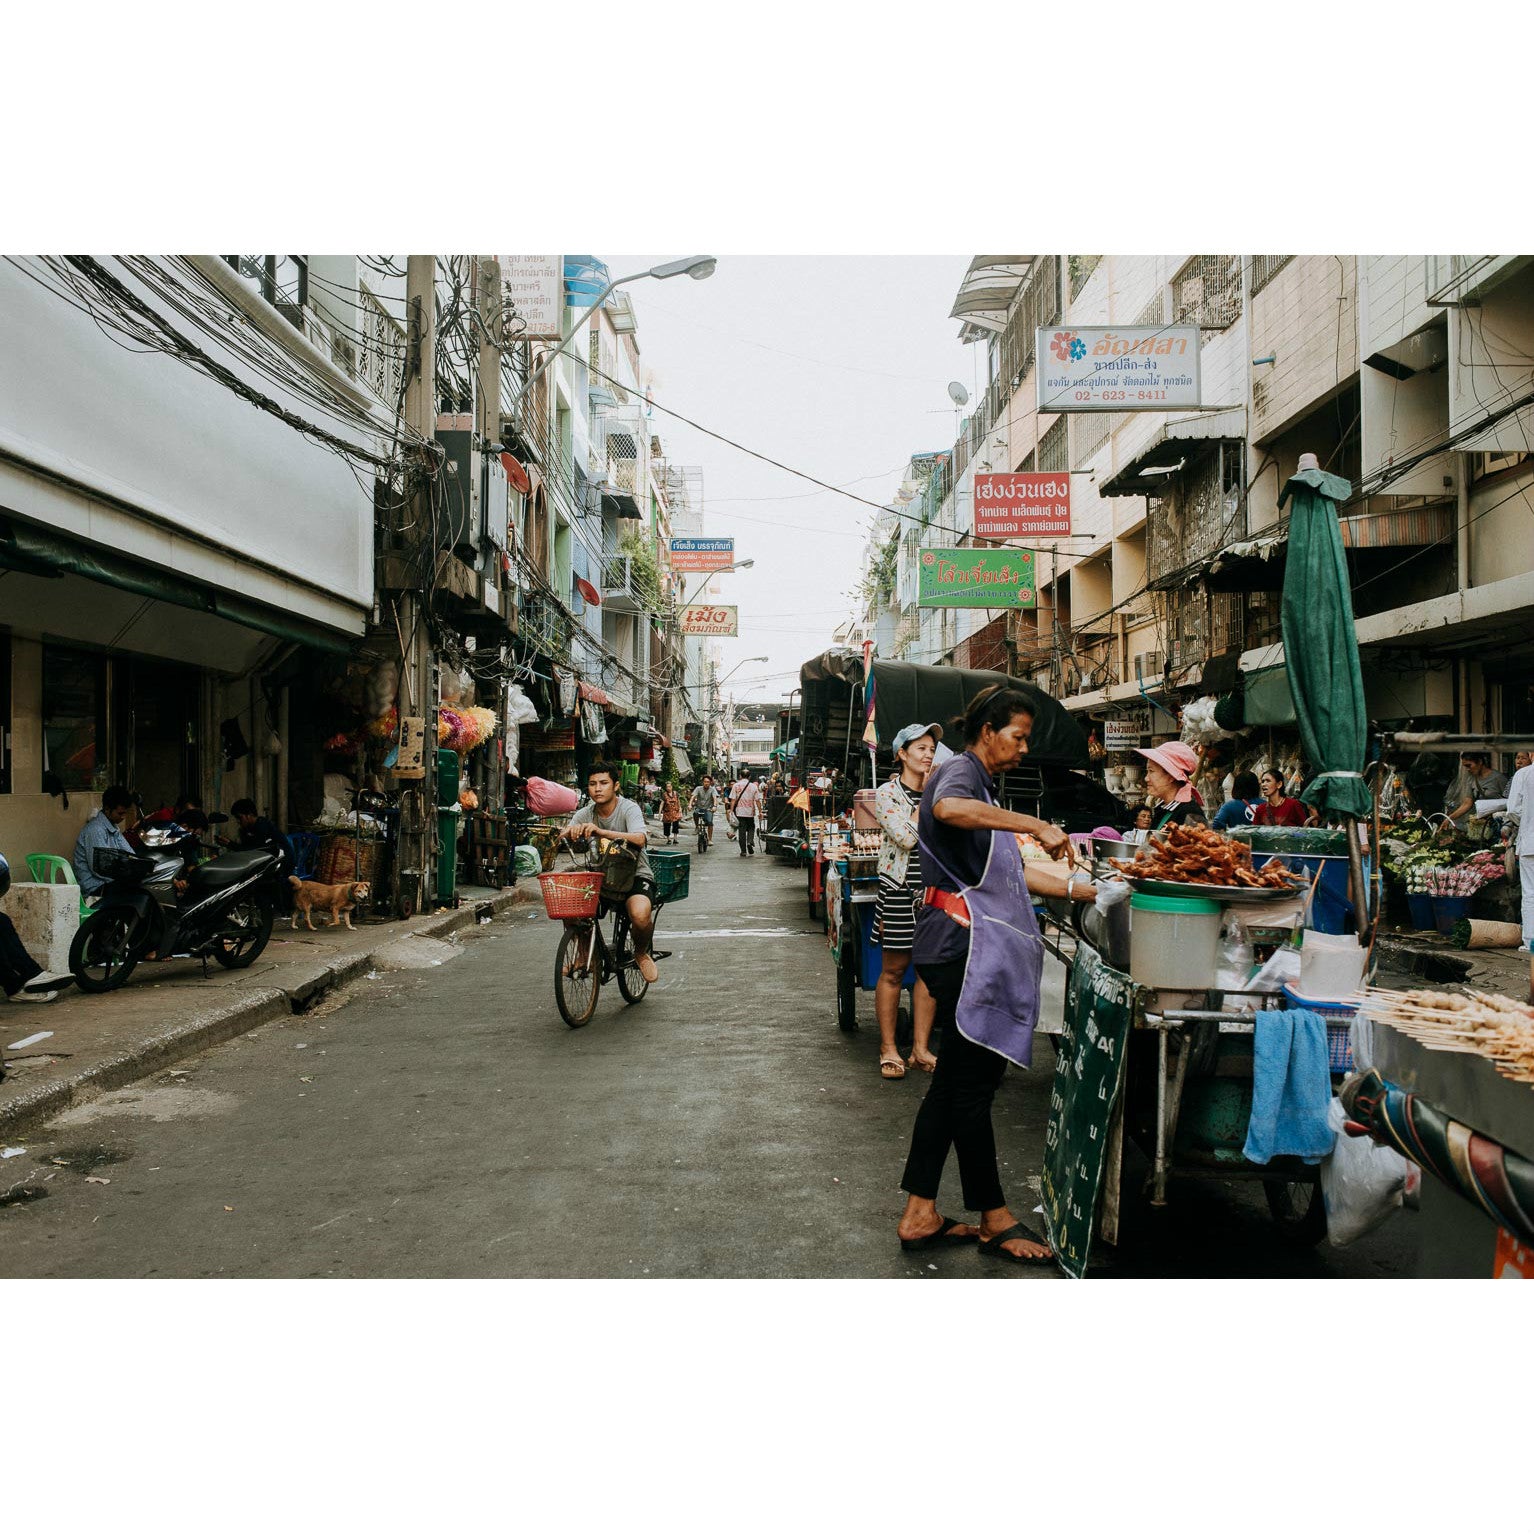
[864,255,1534,757]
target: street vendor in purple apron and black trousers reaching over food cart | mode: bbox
[897,684,1097,1262]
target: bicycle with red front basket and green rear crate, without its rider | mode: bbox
[538,850,687,1028]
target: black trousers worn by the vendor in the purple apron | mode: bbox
[900,959,1006,1209]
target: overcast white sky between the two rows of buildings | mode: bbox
[601,250,983,701]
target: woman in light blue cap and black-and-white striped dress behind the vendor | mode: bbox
[873,724,943,1081]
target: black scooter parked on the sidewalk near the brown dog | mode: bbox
[69,825,291,992]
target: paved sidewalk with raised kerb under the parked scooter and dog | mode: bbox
[0,879,538,1144]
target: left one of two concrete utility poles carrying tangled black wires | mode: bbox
[399,256,437,911]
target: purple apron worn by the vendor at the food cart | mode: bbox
[920,798,1045,1066]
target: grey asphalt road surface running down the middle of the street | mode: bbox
[0,831,1411,1281]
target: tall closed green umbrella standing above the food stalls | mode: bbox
[1279,453,1373,821]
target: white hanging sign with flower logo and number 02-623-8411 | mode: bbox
[1034,325,1203,416]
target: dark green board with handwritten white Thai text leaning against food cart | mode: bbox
[1042,943,1138,1278]
